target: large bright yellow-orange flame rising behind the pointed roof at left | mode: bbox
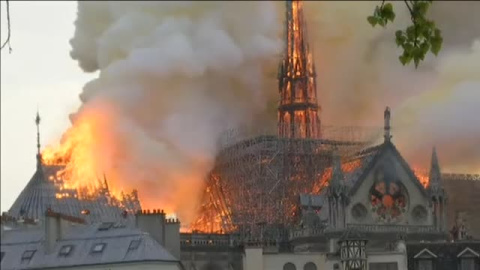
[42,104,134,204]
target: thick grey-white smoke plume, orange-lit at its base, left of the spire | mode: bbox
[67,1,282,223]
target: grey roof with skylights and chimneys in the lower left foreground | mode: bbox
[1,211,184,270]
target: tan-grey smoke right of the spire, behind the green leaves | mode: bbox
[305,1,480,173]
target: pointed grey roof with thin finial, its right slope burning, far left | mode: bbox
[8,114,141,223]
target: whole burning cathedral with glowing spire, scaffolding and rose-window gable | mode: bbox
[1,1,480,270]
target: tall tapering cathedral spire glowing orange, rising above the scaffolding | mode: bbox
[278,0,320,138]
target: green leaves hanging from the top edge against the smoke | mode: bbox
[367,0,443,68]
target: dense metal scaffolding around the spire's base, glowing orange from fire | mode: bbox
[192,123,382,239]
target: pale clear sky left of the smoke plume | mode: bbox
[1,1,95,212]
